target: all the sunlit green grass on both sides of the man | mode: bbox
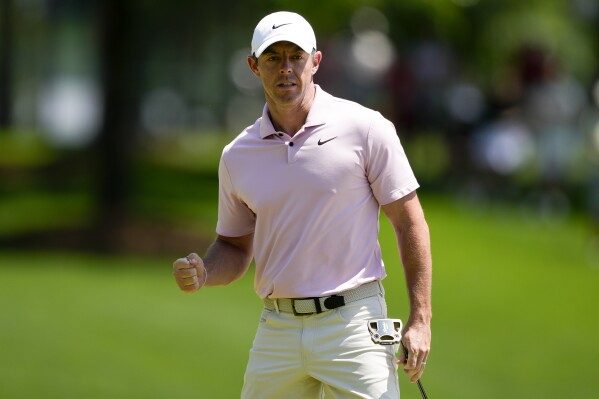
[0,198,599,399]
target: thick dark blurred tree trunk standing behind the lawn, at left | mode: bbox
[94,0,148,249]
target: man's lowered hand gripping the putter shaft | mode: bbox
[397,323,431,382]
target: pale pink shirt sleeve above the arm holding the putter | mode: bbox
[366,112,419,205]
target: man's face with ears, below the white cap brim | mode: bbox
[248,42,322,106]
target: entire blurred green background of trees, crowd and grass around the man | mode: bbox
[0,0,599,399]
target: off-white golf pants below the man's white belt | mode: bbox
[241,294,399,399]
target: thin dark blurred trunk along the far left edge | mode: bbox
[0,0,13,129]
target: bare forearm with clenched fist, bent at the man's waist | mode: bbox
[173,234,254,294]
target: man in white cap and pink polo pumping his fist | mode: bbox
[173,12,432,399]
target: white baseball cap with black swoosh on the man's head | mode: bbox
[252,11,316,57]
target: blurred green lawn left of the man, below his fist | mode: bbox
[0,254,259,398]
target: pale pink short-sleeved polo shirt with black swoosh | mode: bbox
[216,86,418,298]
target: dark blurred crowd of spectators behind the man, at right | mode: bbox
[310,10,599,232]
